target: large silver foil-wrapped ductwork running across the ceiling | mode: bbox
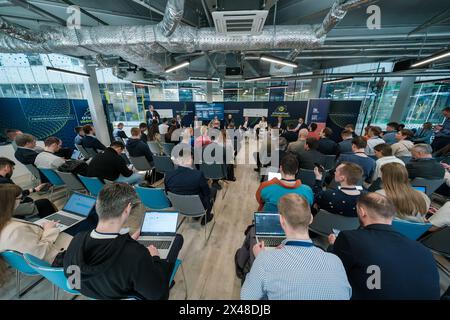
[0,0,369,80]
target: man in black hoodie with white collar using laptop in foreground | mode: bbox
[64,183,183,300]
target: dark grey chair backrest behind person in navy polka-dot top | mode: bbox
[309,210,359,236]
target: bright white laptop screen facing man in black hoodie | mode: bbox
[141,211,178,236]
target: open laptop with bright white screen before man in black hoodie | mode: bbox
[138,211,178,259]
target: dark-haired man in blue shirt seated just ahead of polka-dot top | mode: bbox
[337,137,375,181]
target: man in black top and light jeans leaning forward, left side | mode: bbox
[87,141,144,185]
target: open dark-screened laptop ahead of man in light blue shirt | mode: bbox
[255,212,286,248]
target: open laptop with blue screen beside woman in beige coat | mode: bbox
[34,192,96,231]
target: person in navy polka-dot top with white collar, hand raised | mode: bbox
[313,162,364,217]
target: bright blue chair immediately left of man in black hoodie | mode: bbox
[24,253,80,300]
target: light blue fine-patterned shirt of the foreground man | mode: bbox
[241,240,352,300]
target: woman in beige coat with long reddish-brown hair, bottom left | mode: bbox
[0,184,72,268]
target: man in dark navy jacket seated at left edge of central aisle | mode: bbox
[164,150,217,225]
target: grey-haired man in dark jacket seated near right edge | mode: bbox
[406,143,445,179]
